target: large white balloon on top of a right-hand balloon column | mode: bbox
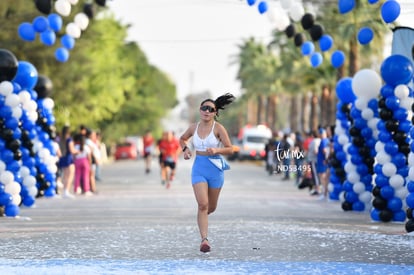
[352,69,382,99]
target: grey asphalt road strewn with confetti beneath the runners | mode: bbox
[0,160,414,274]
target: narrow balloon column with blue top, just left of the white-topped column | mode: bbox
[328,77,355,200]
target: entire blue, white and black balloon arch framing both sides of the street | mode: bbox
[0,0,414,232]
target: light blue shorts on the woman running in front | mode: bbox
[191,155,224,188]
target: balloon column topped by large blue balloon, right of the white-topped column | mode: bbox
[371,55,414,222]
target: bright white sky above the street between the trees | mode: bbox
[107,0,414,104]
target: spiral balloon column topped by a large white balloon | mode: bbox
[342,70,381,211]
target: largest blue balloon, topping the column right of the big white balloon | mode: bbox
[381,54,414,87]
